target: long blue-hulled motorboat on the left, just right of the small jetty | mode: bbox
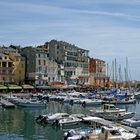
[17,99,47,108]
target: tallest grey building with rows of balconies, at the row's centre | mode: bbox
[48,40,89,84]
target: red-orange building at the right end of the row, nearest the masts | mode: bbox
[89,58,109,87]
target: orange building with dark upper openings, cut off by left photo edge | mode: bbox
[0,52,14,84]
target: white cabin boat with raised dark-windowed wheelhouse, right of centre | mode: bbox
[89,104,126,117]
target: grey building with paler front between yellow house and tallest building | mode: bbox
[21,47,58,86]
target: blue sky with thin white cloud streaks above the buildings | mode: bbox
[0,0,140,80]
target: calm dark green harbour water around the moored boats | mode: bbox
[0,100,140,140]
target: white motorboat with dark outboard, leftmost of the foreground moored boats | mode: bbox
[36,113,69,123]
